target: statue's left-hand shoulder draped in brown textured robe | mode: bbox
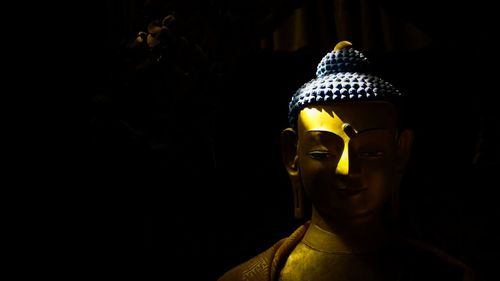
[218,225,307,281]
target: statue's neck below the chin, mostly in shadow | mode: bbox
[311,209,389,253]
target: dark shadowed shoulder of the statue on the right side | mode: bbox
[400,238,477,281]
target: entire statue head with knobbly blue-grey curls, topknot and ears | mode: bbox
[282,41,412,225]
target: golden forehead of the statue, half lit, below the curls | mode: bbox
[298,102,396,134]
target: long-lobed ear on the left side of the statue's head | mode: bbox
[281,128,304,219]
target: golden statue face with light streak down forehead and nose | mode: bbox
[297,102,398,219]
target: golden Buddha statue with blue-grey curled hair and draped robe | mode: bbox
[219,41,476,281]
